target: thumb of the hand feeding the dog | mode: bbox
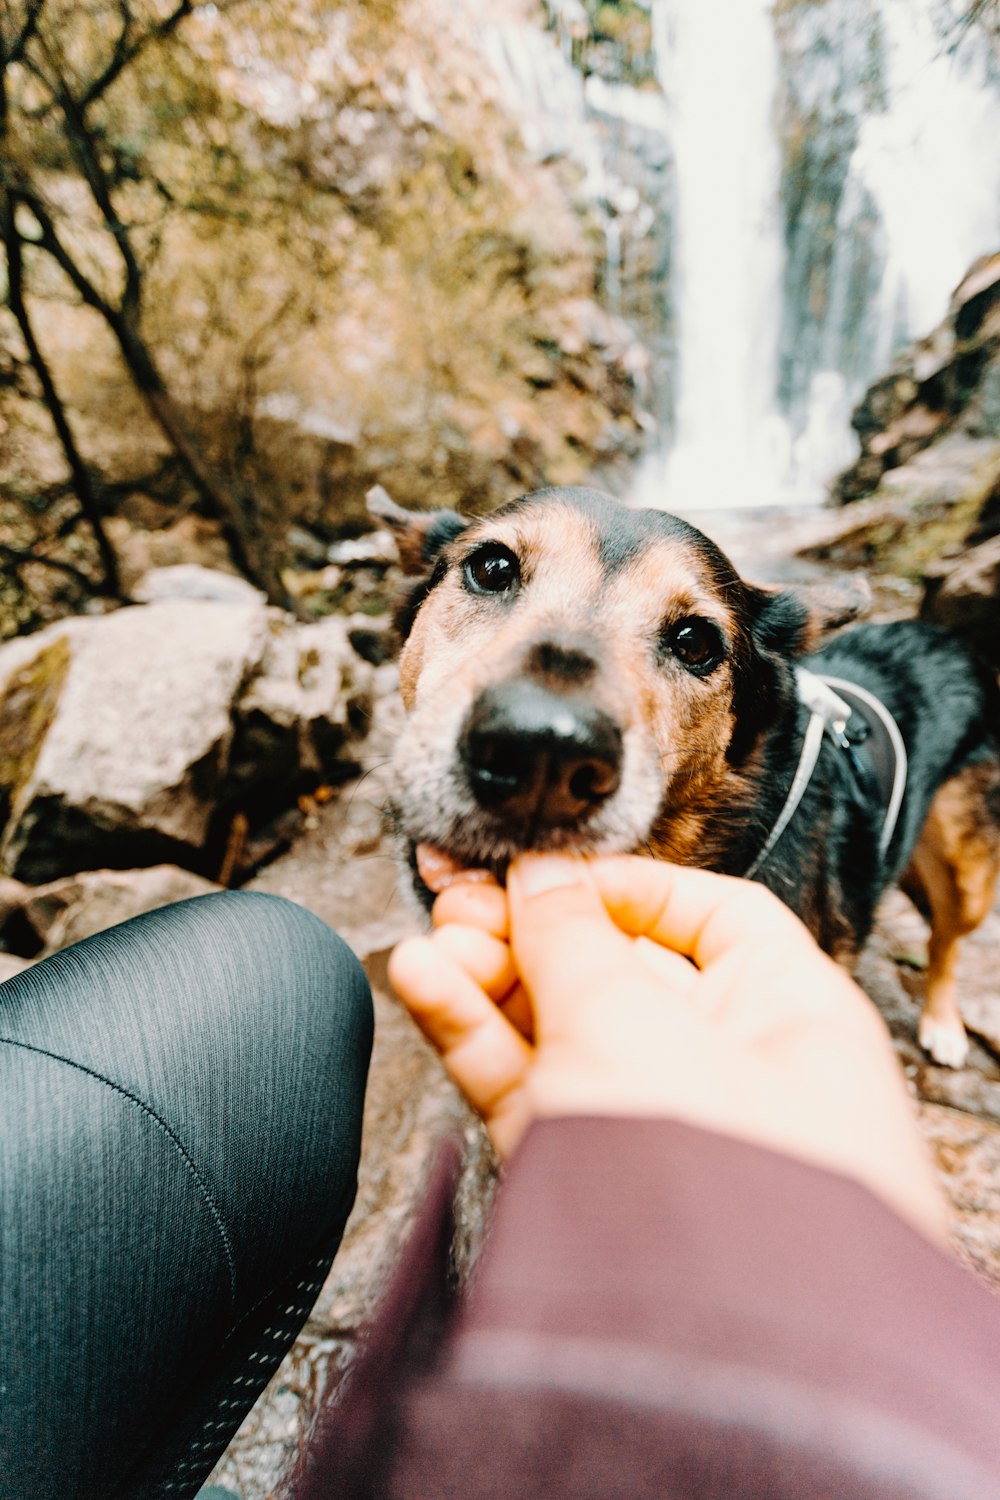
[507,855,634,1035]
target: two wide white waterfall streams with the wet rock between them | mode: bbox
[634,0,1000,510]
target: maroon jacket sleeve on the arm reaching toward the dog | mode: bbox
[296,1118,1000,1500]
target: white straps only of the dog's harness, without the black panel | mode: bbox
[745,666,907,881]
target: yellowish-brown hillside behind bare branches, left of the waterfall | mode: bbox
[0,0,645,635]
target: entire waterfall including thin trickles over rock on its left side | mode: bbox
[473,0,1000,510]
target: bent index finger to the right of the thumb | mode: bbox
[589,855,814,969]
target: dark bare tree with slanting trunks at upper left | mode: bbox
[0,0,283,602]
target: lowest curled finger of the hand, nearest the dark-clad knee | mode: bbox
[388,935,532,1128]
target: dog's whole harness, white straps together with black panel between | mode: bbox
[745,668,907,879]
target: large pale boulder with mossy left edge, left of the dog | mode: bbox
[0,600,267,884]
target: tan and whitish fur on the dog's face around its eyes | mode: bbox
[389,504,742,863]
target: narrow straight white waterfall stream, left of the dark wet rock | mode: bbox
[649,0,789,509]
